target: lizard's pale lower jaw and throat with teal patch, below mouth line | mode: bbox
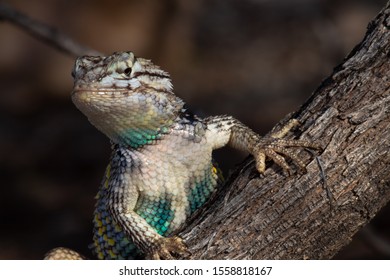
[72,90,183,149]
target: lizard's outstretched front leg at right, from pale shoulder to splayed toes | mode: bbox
[205,116,319,174]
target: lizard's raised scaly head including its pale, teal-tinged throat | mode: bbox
[72,52,184,148]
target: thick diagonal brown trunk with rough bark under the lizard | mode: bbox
[181,2,390,259]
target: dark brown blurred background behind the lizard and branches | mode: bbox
[0,0,390,259]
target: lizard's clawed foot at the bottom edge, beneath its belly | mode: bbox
[146,236,190,260]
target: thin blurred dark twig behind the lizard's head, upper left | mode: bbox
[0,3,102,56]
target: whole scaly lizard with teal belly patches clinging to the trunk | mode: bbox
[46,51,319,259]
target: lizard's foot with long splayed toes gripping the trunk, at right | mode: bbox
[253,119,321,175]
